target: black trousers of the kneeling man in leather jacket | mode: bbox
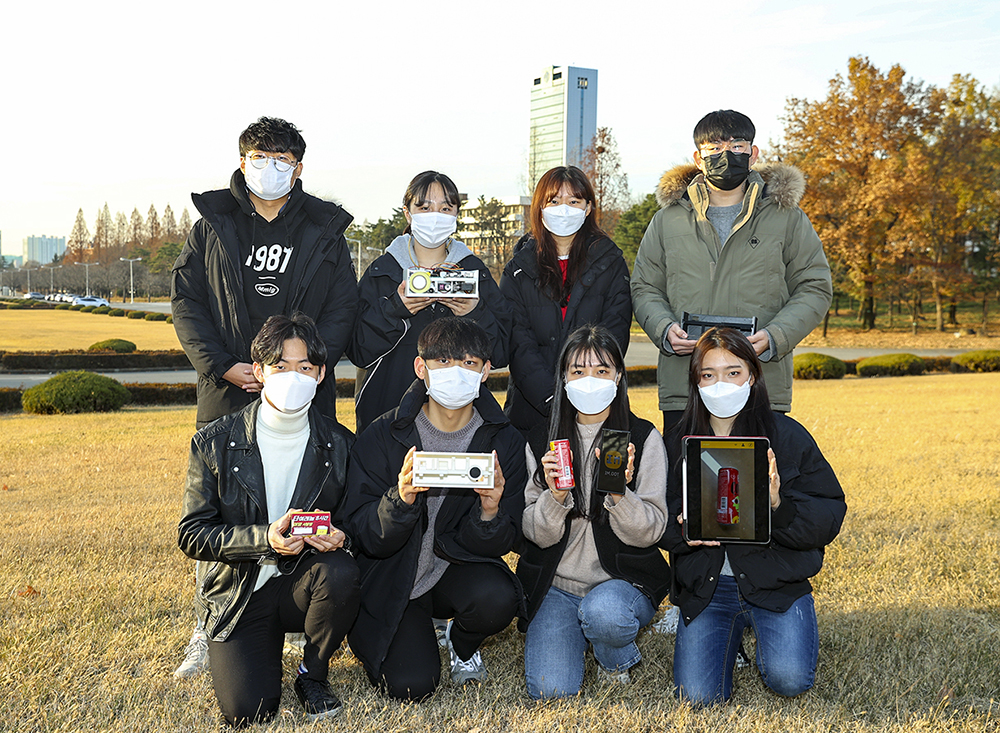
[208,550,360,727]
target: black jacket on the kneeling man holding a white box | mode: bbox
[344,380,527,676]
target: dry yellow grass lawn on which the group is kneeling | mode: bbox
[0,374,1000,733]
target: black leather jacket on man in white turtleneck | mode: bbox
[177,400,354,641]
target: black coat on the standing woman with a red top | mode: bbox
[500,235,632,432]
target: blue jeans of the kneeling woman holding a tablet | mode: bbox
[674,575,819,705]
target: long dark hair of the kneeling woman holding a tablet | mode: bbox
[677,328,774,438]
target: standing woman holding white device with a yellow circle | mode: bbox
[347,171,510,433]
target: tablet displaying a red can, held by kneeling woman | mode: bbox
[681,435,771,544]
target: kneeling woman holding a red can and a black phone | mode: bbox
[517,326,670,699]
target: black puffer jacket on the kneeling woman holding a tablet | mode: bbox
[661,413,847,621]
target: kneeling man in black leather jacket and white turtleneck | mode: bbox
[178,313,359,726]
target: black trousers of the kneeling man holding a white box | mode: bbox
[365,562,518,701]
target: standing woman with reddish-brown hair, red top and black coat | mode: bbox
[500,166,632,434]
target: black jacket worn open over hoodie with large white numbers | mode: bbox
[170,170,358,425]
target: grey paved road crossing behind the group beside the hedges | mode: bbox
[0,340,968,387]
